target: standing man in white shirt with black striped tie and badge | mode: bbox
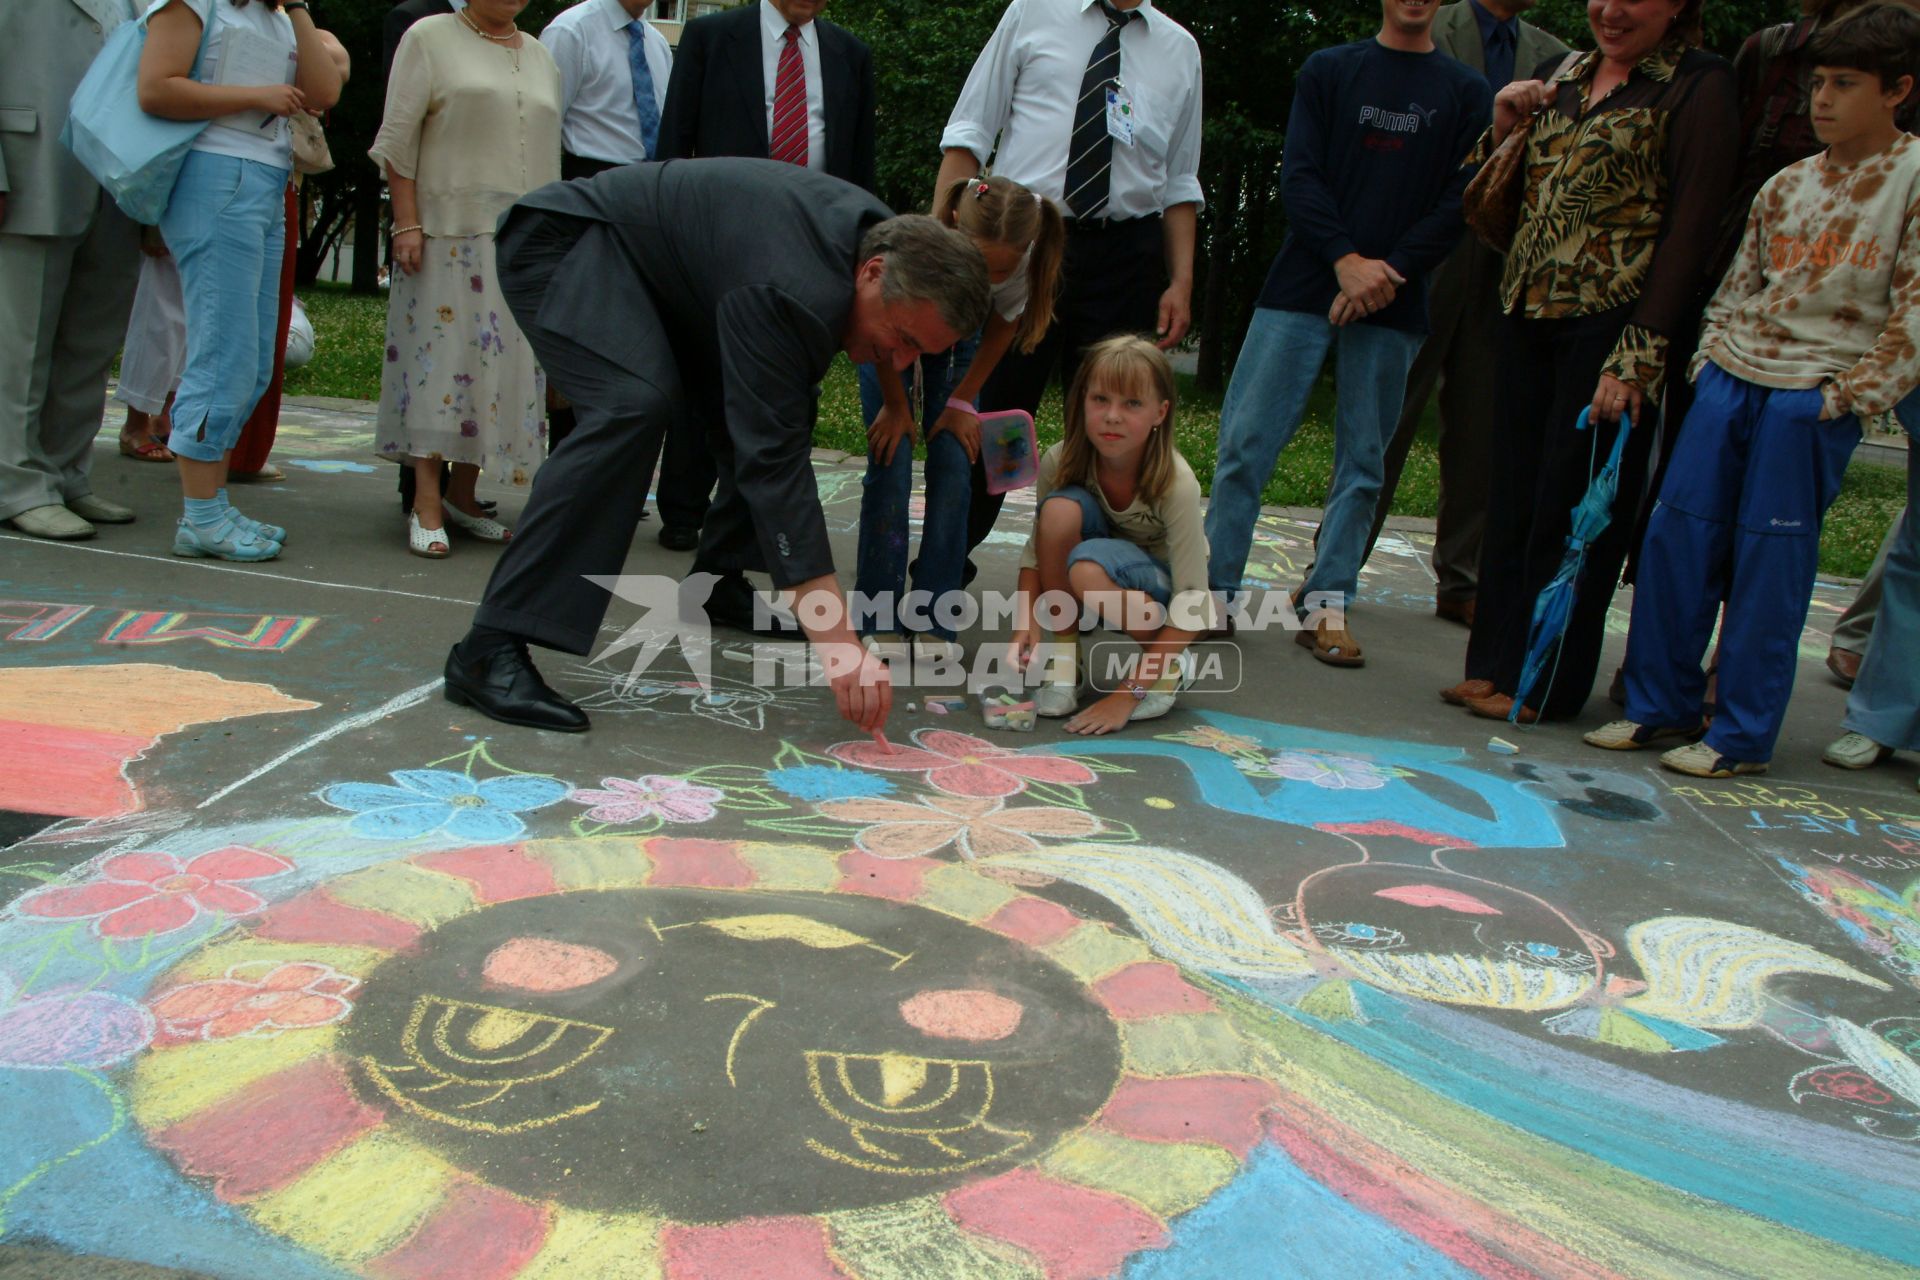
[935,0,1204,576]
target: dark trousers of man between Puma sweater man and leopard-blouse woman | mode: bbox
[1367,234,1505,601]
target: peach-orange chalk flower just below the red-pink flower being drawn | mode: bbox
[820,796,1100,858]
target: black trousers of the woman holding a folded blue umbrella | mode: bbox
[1467,307,1655,718]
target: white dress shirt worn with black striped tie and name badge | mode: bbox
[940,0,1204,219]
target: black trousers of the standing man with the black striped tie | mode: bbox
[966,217,1167,553]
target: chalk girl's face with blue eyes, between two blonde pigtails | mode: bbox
[1294,862,1613,1011]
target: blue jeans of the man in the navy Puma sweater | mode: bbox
[1206,307,1425,603]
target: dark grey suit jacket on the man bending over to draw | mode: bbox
[501,159,893,587]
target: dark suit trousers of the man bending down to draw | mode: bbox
[474,215,685,654]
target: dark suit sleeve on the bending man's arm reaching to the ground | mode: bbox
[714,284,837,587]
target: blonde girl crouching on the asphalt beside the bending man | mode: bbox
[1008,336,1213,735]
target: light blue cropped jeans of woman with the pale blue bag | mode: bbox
[159,152,288,462]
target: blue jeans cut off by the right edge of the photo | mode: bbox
[1845,391,1920,750]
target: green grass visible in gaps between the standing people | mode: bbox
[286,284,1907,578]
